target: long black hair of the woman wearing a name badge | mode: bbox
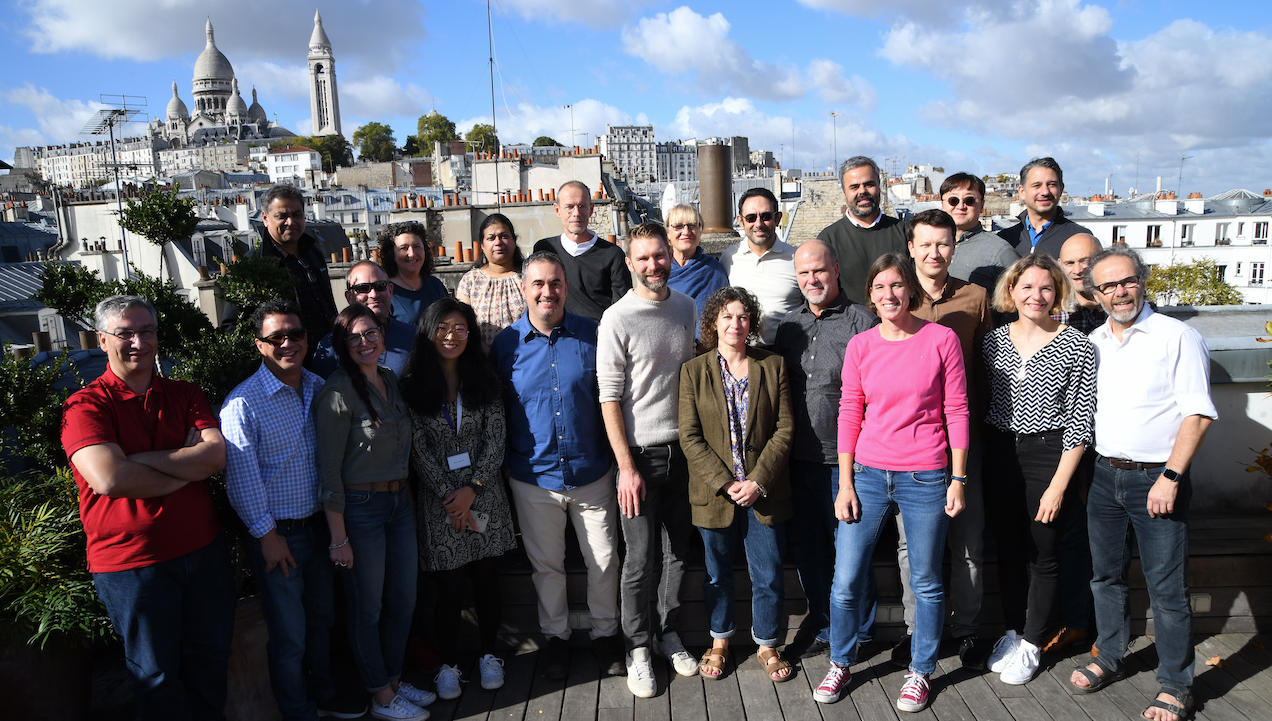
[402,298,502,416]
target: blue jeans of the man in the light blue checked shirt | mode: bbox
[243,511,336,721]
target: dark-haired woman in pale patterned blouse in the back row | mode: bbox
[455,212,525,348]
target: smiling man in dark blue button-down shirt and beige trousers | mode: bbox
[490,252,627,679]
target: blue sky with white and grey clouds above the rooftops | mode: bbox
[0,0,1272,196]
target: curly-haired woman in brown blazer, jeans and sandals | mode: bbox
[681,286,794,682]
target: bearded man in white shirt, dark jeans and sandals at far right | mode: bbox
[1070,245,1217,721]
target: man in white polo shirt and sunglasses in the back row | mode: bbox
[720,188,804,347]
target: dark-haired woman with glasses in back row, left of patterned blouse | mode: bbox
[375,220,450,326]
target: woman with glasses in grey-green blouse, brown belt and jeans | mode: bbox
[314,303,435,721]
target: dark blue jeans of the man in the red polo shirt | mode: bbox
[93,535,234,721]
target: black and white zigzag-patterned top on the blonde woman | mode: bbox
[983,326,1095,450]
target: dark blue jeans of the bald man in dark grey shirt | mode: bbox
[790,460,879,643]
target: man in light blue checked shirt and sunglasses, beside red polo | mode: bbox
[221,299,366,720]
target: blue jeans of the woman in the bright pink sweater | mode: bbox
[831,463,949,675]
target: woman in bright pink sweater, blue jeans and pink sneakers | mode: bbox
[813,253,968,711]
